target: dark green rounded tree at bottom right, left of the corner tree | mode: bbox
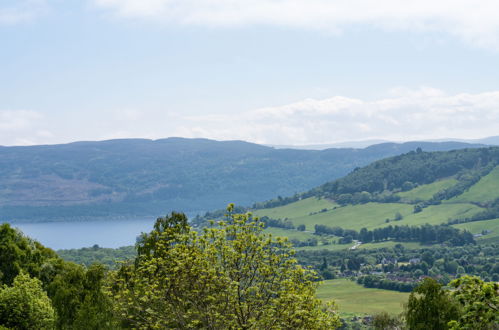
[405,278,459,330]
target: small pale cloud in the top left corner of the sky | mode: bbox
[0,0,48,25]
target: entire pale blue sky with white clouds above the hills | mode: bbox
[0,0,499,146]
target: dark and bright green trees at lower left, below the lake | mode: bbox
[0,224,113,329]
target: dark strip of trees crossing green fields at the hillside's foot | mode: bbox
[315,224,475,246]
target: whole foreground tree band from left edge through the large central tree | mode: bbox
[0,206,339,329]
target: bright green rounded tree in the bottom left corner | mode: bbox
[0,274,55,330]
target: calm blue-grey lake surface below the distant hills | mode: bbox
[11,218,160,250]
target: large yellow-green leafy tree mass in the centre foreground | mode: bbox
[108,204,339,329]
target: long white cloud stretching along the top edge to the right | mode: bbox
[91,0,499,49]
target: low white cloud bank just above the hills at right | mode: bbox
[174,88,499,145]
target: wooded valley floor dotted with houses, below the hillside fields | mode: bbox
[297,244,499,284]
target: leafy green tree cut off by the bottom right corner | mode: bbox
[449,276,499,330]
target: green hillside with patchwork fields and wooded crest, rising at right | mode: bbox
[248,147,499,249]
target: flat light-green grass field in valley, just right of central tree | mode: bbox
[317,279,409,315]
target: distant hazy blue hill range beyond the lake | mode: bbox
[0,138,490,221]
